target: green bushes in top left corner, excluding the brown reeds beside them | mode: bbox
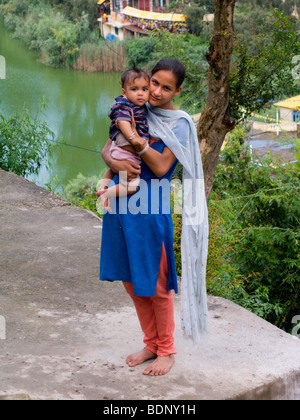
[0,0,92,67]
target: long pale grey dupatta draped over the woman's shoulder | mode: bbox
[148,105,208,344]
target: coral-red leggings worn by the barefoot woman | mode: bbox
[123,244,176,356]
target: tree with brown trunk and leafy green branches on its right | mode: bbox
[197,0,300,197]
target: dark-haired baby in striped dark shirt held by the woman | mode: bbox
[97,69,150,211]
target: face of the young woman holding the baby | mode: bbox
[149,70,182,109]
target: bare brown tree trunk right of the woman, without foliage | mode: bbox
[197,0,235,197]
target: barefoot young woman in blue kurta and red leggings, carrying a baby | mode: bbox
[100,59,208,376]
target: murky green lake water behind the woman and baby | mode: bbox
[0,21,121,190]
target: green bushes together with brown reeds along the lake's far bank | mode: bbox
[0,0,125,72]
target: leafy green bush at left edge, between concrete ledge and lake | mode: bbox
[0,106,54,177]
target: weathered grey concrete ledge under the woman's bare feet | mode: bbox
[0,170,300,400]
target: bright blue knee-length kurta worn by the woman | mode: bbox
[100,141,178,296]
